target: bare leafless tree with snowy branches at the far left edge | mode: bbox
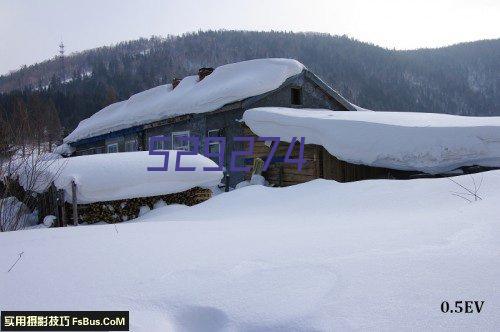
[0,101,65,232]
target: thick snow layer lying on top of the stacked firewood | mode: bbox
[13,151,222,204]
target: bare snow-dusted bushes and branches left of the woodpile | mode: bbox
[0,101,64,231]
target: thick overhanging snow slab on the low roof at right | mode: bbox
[243,107,500,173]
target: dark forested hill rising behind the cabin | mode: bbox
[0,31,500,134]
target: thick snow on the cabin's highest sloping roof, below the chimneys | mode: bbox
[64,59,305,143]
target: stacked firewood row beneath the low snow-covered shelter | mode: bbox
[66,187,212,224]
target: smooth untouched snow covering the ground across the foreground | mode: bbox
[0,171,500,332]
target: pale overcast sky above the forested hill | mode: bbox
[0,0,500,74]
